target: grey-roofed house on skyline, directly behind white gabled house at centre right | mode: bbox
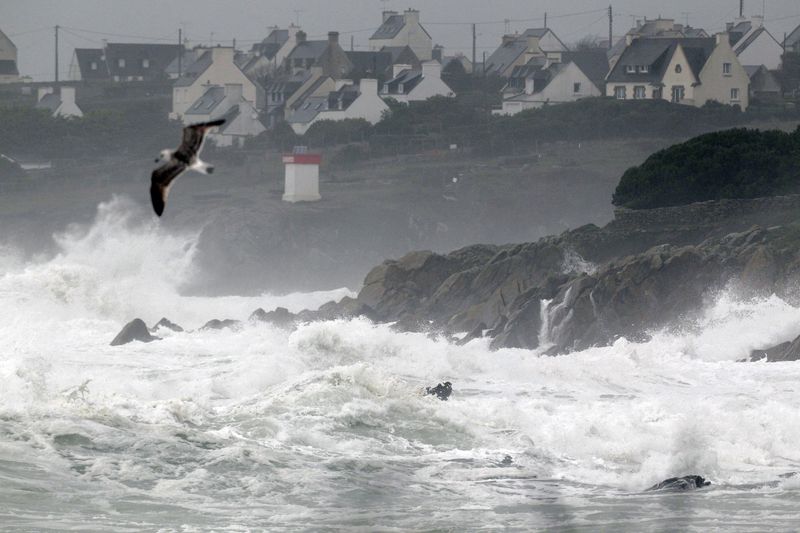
[484,28,569,78]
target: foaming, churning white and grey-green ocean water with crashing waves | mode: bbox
[0,199,800,532]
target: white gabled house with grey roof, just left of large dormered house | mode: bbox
[494,49,608,115]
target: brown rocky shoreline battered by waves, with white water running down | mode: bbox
[112,196,800,360]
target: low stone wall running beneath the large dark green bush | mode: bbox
[611,194,800,230]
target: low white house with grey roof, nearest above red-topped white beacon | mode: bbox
[286,78,389,135]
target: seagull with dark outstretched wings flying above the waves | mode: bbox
[150,119,225,216]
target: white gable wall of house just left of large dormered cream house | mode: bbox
[495,63,602,115]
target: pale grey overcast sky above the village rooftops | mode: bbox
[0,0,800,80]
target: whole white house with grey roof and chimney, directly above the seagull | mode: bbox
[170,46,263,119]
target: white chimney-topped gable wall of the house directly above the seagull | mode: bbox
[172,46,258,119]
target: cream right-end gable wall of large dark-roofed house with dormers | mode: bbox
[695,34,750,111]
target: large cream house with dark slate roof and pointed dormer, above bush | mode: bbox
[606,33,750,110]
